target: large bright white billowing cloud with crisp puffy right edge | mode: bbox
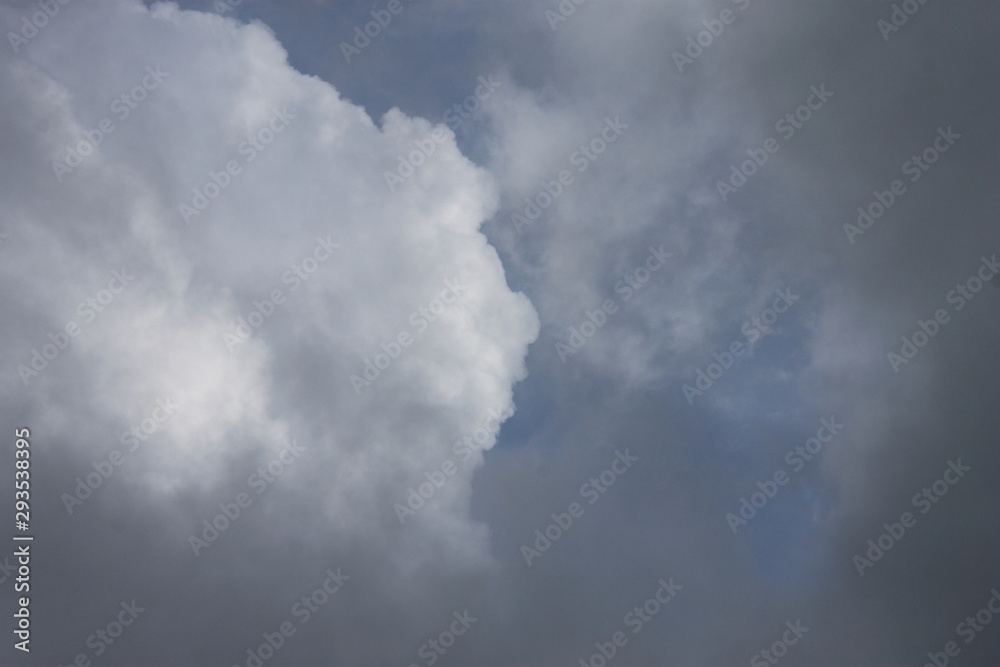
[0,2,538,659]
